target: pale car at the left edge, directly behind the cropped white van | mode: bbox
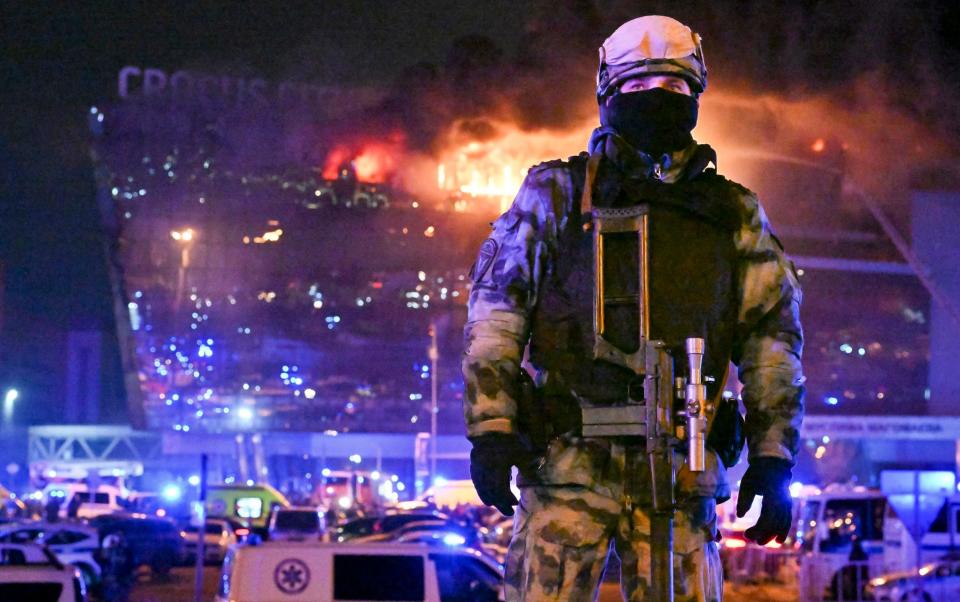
[0,521,101,590]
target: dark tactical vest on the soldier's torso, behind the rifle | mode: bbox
[529,149,742,434]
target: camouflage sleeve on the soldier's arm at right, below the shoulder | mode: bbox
[733,191,805,464]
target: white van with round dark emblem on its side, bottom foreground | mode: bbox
[217,541,503,602]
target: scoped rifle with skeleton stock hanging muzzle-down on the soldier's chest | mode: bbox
[581,165,710,602]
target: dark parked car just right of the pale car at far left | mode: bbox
[90,514,184,575]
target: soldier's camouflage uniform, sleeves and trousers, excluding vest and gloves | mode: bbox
[463,134,803,600]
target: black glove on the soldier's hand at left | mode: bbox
[470,433,528,516]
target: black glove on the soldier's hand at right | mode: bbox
[737,458,793,545]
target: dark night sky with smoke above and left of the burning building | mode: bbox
[0,0,960,420]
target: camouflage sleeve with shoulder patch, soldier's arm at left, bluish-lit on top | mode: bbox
[462,170,560,437]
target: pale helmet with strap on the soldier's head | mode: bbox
[597,15,707,101]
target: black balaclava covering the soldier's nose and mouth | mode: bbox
[600,88,700,157]
